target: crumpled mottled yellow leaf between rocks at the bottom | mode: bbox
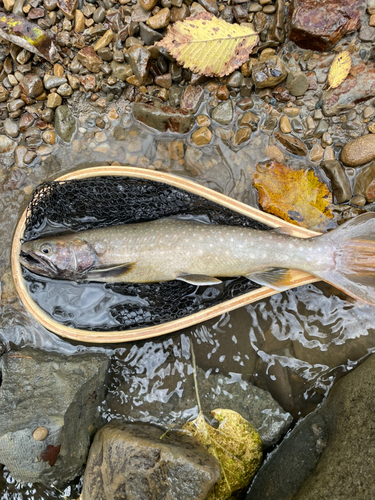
[182,409,262,500]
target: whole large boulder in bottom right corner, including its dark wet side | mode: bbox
[247,355,375,500]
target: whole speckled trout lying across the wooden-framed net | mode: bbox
[20,213,375,304]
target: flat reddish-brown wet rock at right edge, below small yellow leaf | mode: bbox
[322,61,375,116]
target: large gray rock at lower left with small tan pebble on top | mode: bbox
[0,348,109,484]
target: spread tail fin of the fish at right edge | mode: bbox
[316,213,375,305]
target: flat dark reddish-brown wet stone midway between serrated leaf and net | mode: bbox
[133,102,194,134]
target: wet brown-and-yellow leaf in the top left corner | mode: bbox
[0,12,58,63]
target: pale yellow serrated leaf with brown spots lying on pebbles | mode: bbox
[155,12,259,76]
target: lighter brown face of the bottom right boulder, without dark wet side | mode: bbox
[293,356,375,500]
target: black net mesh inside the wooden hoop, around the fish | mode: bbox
[23,176,269,331]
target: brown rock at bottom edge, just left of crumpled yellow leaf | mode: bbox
[81,422,220,500]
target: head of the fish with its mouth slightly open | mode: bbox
[20,235,97,279]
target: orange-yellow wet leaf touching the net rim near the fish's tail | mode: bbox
[253,161,334,231]
